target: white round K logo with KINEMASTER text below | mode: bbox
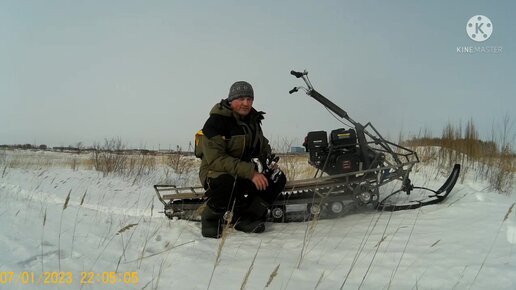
[457,15,503,54]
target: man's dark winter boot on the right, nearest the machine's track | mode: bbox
[235,196,269,233]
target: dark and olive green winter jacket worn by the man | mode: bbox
[199,100,271,187]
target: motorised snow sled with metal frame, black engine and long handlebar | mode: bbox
[154,71,460,222]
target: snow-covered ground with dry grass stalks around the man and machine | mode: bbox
[0,152,516,289]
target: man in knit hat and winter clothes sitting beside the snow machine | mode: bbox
[196,81,286,238]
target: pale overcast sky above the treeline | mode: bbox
[0,0,516,149]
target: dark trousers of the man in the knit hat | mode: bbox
[206,174,287,211]
